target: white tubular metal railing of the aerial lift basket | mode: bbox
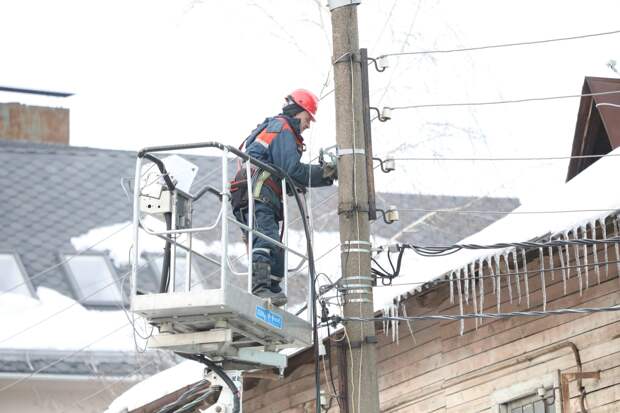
[130,142,315,321]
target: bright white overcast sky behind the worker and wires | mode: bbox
[0,0,620,198]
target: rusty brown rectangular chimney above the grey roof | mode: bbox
[0,103,69,145]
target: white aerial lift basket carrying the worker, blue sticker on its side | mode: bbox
[130,142,313,370]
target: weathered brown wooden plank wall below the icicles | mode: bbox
[244,224,620,413]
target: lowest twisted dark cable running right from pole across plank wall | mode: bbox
[331,305,620,323]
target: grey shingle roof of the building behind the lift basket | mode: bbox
[0,139,519,374]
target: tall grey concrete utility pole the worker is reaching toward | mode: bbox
[328,0,379,413]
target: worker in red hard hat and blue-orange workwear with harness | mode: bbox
[231,89,337,306]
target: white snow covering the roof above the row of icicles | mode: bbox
[374,148,620,309]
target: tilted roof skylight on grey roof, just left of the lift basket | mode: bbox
[63,254,122,305]
